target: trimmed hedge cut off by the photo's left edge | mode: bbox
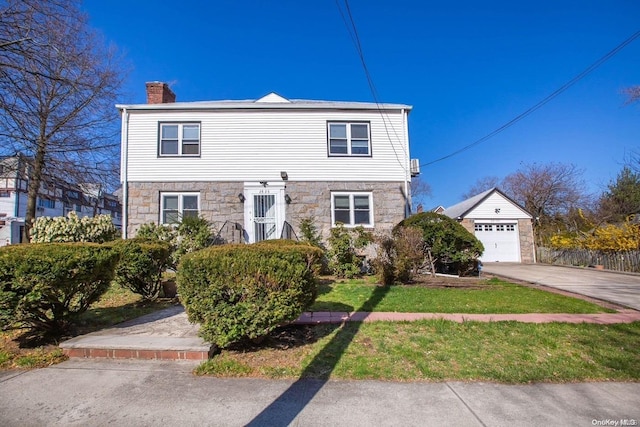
[0,243,118,336]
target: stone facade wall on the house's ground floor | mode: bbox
[127,181,405,240]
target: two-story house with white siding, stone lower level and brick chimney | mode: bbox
[117,82,418,243]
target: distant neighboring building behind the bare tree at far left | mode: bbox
[0,157,122,246]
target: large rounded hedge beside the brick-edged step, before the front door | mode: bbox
[177,241,322,348]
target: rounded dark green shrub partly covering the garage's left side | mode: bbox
[394,212,484,275]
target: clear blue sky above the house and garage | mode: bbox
[84,0,640,207]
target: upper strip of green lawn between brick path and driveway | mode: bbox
[310,279,614,314]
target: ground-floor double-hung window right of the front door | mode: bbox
[331,193,373,227]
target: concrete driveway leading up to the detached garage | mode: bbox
[482,262,640,310]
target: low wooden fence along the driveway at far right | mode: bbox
[536,247,640,273]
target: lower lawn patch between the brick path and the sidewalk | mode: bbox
[196,320,640,383]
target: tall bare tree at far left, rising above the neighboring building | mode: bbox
[0,0,123,240]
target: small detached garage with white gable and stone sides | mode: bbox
[442,188,535,263]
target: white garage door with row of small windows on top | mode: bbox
[475,223,520,262]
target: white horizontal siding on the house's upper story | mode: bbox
[127,110,411,182]
